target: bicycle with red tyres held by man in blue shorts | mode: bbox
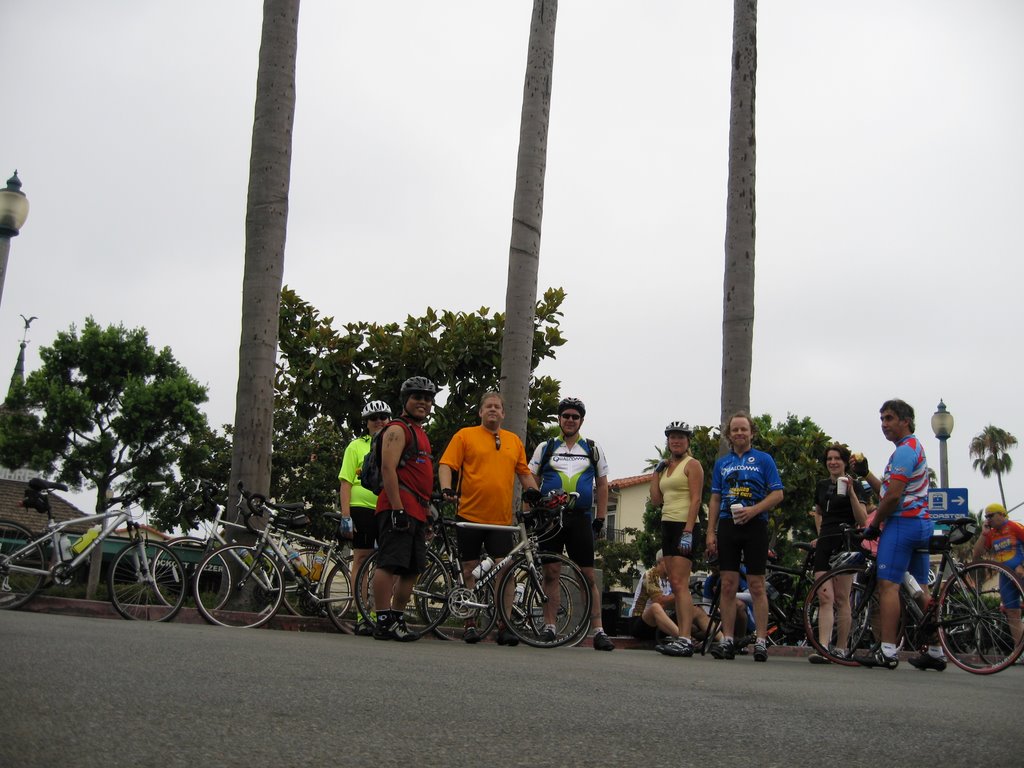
[805,517,1024,675]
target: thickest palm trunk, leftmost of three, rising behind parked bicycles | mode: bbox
[230,0,299,501]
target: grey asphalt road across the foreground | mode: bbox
[0,611,1024,768]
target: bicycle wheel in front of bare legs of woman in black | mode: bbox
[804,565,881,667]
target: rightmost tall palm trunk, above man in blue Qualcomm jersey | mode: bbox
[719,0,758,454]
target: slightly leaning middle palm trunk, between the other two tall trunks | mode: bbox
[501,0,558,440]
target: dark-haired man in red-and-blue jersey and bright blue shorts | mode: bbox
[854,399,946,672]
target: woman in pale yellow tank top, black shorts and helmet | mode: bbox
[650,421,703,656]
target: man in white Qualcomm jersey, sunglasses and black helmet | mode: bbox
[529,397,615,650]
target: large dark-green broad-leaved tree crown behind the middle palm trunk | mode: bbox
[274,288,565,474]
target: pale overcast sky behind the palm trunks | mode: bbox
[0,0,1024,519]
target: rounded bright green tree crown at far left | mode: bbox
[0,317,209,511]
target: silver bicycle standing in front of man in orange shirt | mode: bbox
[355,492,592,647]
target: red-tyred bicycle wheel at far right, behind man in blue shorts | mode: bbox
[938,562,1024,675]
